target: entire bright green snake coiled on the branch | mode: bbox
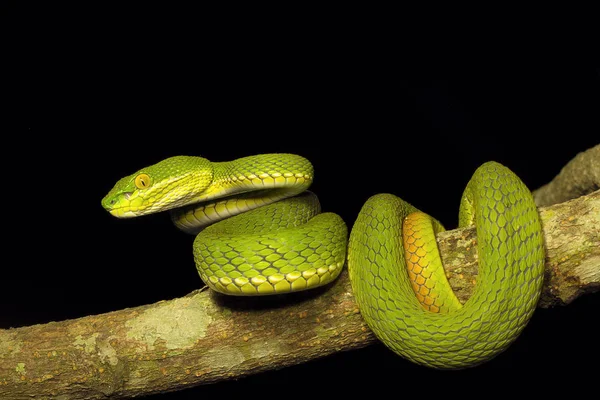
[102,154,545,369]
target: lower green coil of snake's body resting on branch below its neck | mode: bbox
[194,192,348,295]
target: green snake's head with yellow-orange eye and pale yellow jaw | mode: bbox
[102,156,213,218]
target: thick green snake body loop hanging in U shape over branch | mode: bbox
[348,162,545,369]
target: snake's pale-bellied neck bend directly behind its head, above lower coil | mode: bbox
[171,154,313,234]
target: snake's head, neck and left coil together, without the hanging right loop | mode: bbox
[102,154,348,296]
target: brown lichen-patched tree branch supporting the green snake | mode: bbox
[0,146,600,400]
